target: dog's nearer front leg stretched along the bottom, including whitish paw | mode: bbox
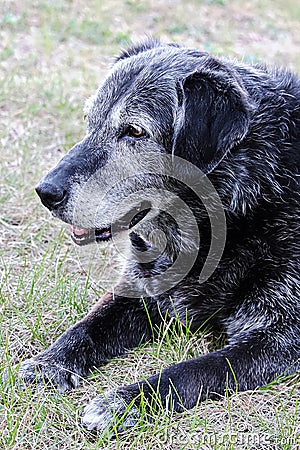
[82,330,300,432]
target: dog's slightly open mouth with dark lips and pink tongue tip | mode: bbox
[69,201,151,245]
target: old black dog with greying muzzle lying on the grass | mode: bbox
[19,39,300,432]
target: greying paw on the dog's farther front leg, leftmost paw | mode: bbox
[16,357,80,393]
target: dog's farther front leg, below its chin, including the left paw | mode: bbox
[14,293,156,392]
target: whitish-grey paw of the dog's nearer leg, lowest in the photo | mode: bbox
[82,391,140,435]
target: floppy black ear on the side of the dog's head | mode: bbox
[173,71,251,173]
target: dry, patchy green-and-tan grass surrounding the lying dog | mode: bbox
[0,0,300,450]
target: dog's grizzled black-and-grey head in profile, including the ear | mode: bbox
[36,41,251,244]
